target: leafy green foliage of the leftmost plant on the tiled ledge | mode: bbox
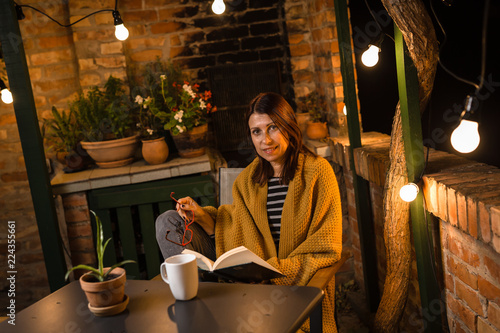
[42,106,83,152]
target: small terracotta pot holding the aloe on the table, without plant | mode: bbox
[80,267,127,308]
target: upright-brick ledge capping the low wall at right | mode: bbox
[307,132,500,253]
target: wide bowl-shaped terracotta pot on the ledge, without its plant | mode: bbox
[81,135,139,168]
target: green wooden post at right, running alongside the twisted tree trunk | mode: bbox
[394,25,443,332]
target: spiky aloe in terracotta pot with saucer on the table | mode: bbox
[65,211,135,315]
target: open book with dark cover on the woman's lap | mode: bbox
[182,246,283,282]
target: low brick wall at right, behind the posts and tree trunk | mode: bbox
[331,133,500,332]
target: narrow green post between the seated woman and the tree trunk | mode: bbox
[334,0,380,312]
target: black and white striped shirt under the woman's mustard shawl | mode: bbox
[267,177,288,250]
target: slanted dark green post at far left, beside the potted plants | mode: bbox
[0,1,67,291]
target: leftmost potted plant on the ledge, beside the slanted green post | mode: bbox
[42,106,91,173]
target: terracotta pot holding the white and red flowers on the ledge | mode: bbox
[172,124,208,158]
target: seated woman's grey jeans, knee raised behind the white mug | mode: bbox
[156,210,216,261]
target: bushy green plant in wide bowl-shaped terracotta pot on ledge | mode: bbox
[74,76,139,168]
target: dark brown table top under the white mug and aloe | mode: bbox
[0,280,323,333]
